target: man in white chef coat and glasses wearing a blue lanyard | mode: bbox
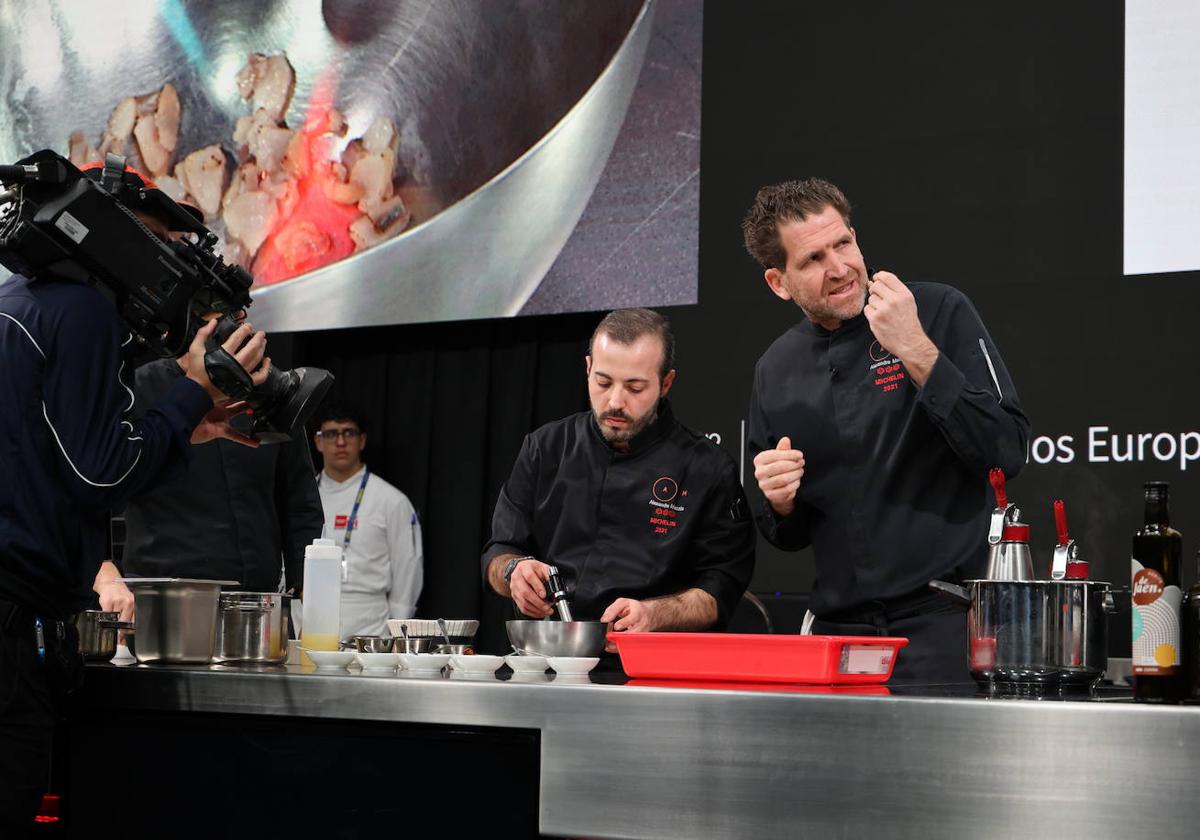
[316,402,425,638]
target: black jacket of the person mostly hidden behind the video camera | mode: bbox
[121,359,324,592]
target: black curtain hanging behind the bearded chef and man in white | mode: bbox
[285,314,599,653]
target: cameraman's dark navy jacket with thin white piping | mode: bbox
[0,276,212,618]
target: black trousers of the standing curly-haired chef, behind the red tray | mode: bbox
[812,593,971,684]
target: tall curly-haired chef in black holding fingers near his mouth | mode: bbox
[743,179,1030,682]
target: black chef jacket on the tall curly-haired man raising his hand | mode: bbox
[749,283,1030,617]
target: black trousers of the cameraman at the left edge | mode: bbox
[0,601,83,838]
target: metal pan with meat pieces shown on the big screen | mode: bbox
[0,0,654,331]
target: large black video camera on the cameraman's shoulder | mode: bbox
[0,150,332,443]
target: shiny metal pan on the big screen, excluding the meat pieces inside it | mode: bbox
[0,0,654,331]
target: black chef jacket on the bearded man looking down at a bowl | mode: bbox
[482,401,755,625]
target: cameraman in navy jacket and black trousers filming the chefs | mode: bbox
[0,166,270,836]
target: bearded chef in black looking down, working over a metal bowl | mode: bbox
[482,310,755,649]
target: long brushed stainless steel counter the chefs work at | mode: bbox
[84,665,1200,840]
